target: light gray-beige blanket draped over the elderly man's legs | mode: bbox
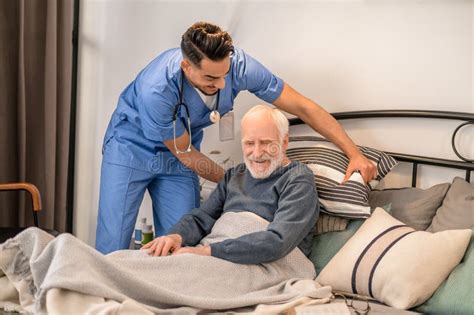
[0,212,330,312]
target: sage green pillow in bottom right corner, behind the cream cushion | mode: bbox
[416,230,474,314]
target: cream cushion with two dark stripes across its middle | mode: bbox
[316,208,471,309]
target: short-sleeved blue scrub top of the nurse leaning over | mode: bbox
[103,47,283,175]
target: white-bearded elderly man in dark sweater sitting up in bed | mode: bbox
[143,105,319,264]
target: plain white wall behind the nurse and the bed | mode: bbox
[74,0,474,244]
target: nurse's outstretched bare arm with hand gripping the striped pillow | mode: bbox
[273,83,376,183]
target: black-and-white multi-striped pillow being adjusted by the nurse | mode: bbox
[286,137,397,219]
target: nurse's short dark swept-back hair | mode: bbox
[181,22,234,66]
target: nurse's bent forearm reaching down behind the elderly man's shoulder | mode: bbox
[163,131,224,183]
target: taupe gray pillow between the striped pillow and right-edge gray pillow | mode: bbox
[369,183,450,231]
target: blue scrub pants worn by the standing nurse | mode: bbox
[95,161,199,254]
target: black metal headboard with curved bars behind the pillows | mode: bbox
[290,110,474,187]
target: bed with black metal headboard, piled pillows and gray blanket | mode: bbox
[0,111,474,314]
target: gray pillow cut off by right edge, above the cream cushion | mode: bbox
[427,177,474,232]
